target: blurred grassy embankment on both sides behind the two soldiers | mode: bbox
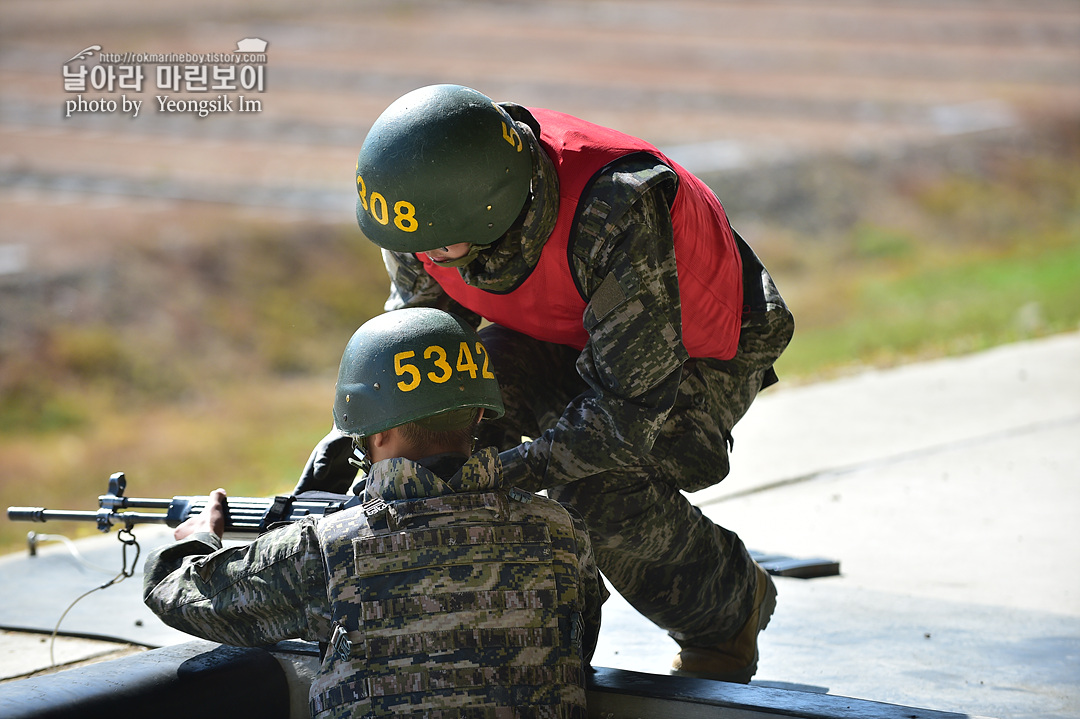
[0,123,1080,551]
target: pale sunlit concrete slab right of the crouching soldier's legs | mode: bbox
[595,334,1080,719]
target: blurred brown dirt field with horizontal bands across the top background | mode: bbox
[0,0,1080,272]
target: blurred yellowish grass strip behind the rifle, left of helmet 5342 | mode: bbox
[0,376,334,552]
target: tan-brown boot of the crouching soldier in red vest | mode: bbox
[672,564,777,684]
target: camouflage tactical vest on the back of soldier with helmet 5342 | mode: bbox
[311,483,586,719]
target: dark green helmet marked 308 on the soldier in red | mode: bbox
[356,85,532,253]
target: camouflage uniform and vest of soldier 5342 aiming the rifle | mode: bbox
[145,449,606,718]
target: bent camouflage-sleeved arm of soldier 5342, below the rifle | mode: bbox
[143,519,329,647]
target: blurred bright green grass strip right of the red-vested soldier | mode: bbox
[778,237,1080,378]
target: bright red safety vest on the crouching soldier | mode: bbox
[417,108,743,360]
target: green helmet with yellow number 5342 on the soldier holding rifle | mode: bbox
[334,308,503,437]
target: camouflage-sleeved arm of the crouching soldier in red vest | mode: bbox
[500,159,687,490]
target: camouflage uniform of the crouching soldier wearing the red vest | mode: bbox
[383,104,794,647]
